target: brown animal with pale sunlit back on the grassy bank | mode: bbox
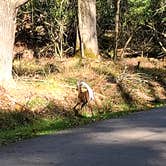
[73,81,95,116]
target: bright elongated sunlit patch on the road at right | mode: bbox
[88,128,166,144]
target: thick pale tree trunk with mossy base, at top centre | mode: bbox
[78,0,99,58]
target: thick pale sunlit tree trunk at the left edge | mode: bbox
[0,0,28,84]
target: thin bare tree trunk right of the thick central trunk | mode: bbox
[114,0,121,60]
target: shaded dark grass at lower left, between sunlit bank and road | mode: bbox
[0,102,77,146]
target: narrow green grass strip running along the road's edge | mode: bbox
[0,105,165,146]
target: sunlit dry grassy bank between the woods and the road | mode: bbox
[0,57,166,144]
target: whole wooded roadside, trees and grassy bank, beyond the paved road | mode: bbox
[0,0,166,144]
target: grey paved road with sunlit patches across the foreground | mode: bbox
[0,108,166,166]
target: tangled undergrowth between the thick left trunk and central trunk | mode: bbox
[16,0,76,57]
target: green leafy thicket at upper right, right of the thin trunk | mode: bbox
[120,0,166,56]
